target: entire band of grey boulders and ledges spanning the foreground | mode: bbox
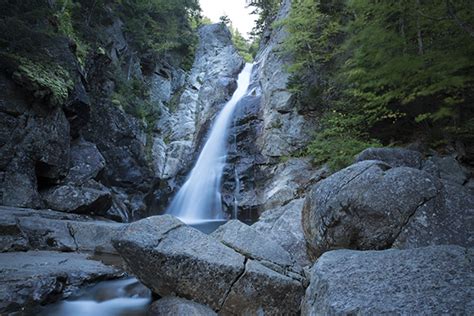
[0,148,474,315]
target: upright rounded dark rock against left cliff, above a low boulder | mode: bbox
[64,140,105,184]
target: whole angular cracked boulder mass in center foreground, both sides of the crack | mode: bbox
[114,215,304,315]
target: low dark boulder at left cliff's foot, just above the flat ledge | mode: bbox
[41,180,112,214]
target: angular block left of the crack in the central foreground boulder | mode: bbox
[113,215,244,310]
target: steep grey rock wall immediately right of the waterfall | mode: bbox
[223,0,325,222]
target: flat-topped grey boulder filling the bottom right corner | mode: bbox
[302,246,474,315]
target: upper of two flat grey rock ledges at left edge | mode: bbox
[0,207,123,254]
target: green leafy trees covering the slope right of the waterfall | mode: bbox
[284,0,474,167]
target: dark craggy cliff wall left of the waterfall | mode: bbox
[0,10,243,221]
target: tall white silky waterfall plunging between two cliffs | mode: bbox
[166,64,253,224]
